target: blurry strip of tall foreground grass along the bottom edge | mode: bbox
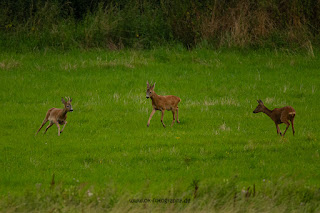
[0,177,320,212]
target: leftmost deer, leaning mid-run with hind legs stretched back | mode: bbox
[36,98,73,136]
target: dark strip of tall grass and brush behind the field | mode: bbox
[0,0,320,49]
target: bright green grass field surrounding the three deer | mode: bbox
[0,48,320,211]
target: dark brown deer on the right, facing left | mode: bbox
[253,100,296,136]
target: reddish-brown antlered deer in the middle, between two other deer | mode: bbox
[146,82,181,127]
